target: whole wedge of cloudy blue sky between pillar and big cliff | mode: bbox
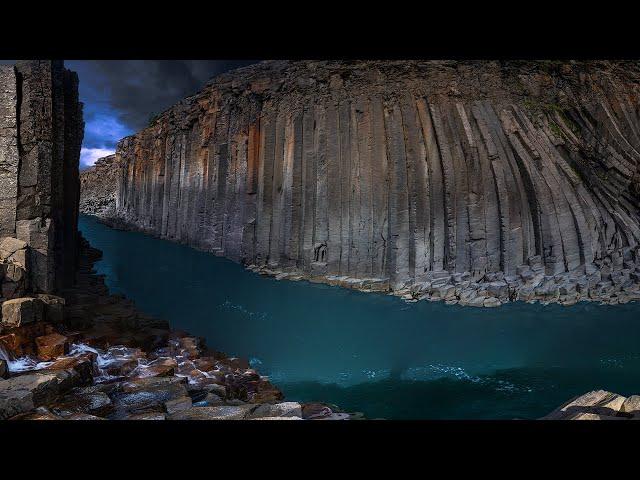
[0,60,254,169]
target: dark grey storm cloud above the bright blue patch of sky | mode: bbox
[76,60,254,130]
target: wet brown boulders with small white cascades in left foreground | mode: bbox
[0,240,358,420]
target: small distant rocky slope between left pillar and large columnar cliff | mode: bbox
[80,155,118,216]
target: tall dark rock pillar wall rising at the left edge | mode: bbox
[0,60,84,299]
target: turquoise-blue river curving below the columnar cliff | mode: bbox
[80,216,640,419]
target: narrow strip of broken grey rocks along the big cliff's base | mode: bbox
[95,212,640,308]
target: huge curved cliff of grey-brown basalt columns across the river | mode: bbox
[101,61,640,306]
